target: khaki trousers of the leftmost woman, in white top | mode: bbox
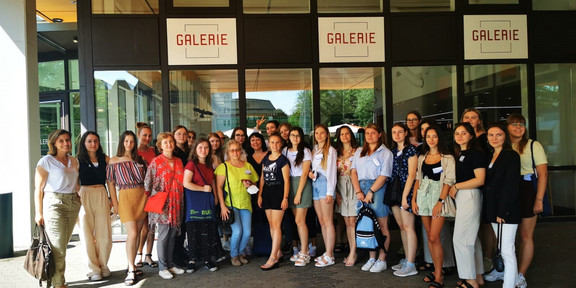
[42,193,80,286]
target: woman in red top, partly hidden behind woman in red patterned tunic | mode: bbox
[136,122,158,268]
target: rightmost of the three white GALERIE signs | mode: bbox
[464,15,528,60]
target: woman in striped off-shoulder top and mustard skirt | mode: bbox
[106,131,146,286]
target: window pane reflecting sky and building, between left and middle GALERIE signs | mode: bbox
[246,69,313,134]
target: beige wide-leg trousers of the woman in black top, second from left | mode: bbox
[78,186,112,277]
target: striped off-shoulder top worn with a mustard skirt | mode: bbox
[106,161,146,190]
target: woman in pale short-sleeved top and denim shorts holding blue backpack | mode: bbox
[350,123,393,273]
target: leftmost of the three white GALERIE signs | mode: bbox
[166,18,238,65]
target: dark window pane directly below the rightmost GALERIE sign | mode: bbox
[464,64,528,124]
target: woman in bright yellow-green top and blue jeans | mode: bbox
[214,140,259,266]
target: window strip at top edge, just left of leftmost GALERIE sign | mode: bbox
[92,0,158,14]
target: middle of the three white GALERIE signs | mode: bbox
[318,17,384,63]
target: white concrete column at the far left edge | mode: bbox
[0,0,40,250]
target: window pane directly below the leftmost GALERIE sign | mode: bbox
[170,70,240,137]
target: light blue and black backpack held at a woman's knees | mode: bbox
[356,203,386,252]
